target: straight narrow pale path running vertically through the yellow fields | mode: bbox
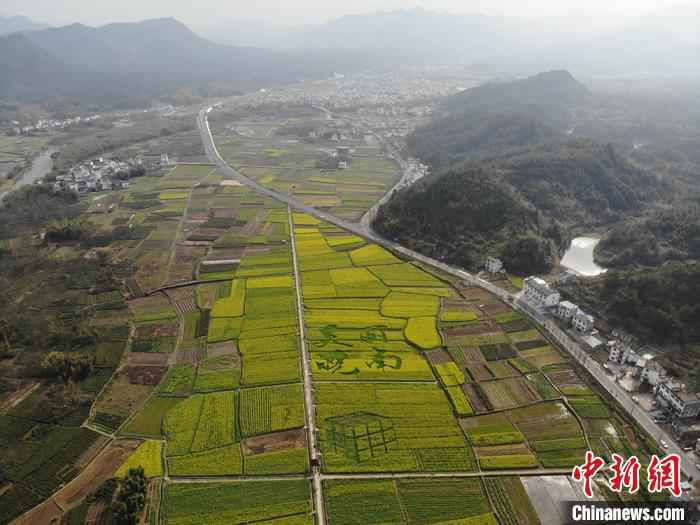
[287,207,326,525]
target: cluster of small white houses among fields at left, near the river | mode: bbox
[53,153,170,193]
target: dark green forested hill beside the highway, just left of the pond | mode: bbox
[374,140,665,273]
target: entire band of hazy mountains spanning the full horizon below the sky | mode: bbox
[0,8,700,106]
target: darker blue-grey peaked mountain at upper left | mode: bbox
[0,18,320,104]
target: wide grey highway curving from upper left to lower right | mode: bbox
[197,106,700,479]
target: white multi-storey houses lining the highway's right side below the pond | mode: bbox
[520,272,700,444]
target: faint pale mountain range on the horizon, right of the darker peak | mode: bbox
[197,7,700,76]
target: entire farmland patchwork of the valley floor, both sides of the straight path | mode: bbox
[0,157,664,525]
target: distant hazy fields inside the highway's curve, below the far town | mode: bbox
[214,106,400,221]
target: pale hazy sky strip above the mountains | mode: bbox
[0,0,688,25]
